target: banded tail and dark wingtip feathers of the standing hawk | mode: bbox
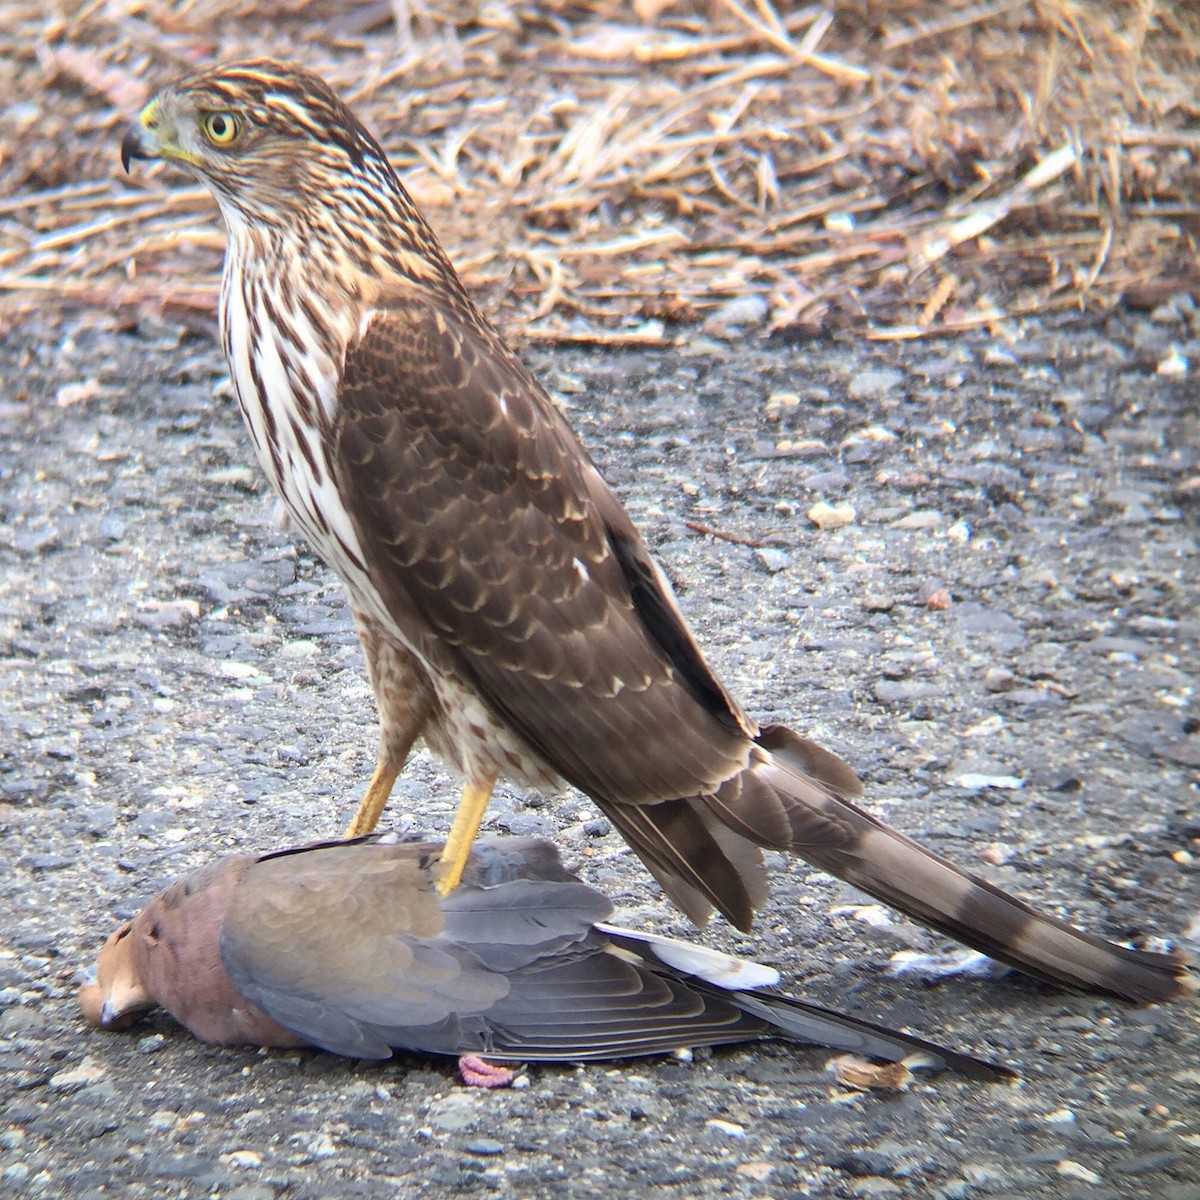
[608,725,1196,1001]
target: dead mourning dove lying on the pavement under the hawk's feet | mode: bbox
[79,838,1010,1086]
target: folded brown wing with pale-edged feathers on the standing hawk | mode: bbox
[337,298,754,804]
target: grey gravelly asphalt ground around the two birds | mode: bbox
[0,307,1200,1200]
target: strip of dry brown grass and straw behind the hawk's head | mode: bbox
[0,0,1200,342]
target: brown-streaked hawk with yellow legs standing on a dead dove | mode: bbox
[121,60,1187,998]
